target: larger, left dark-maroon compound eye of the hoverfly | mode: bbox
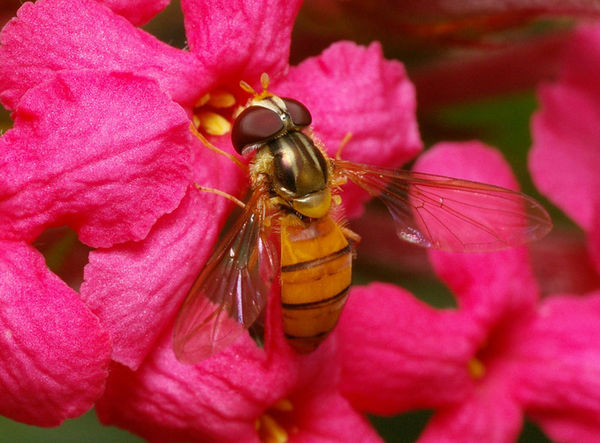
[231,106,283,154]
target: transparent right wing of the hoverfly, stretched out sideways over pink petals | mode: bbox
[334,160,552,252]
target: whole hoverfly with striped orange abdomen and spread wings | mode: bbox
[173,77,552,362]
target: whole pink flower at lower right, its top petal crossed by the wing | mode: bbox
[337,142,600,442]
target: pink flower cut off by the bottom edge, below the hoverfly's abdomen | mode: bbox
[97,286,381,442]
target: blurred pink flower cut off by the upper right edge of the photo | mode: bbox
[529,26,600,273]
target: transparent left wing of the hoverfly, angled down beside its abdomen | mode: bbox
[173,191,276,363]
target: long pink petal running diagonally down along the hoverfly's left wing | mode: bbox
[81,131,247,369]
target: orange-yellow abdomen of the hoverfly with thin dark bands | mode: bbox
[281,215,352,352]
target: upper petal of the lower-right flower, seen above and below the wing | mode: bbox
[415,142,538,321]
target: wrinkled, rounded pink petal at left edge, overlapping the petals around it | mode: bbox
[0,71,190,246]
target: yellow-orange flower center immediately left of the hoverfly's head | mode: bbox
[193,89,238,136]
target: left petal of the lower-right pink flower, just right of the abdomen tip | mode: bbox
[336,283,478,414]
